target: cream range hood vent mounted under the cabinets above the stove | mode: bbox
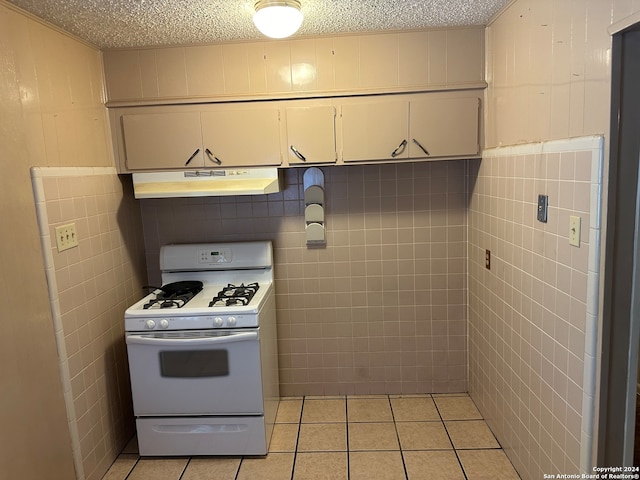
[133,168,280,198]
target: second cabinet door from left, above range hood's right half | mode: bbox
[201,109,282,167]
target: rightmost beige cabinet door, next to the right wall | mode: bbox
[409,97,480,158]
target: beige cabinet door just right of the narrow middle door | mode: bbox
[341,101,409,162]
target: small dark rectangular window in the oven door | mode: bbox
[159,349,229,378]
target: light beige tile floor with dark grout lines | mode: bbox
[103,394,520,480]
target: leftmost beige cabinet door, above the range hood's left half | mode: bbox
[122,112,204,170]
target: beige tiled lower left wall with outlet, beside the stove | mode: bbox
[32,167,146,480]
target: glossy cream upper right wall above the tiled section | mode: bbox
[485,0,640,148]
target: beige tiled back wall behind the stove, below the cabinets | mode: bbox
[141,161,468,395]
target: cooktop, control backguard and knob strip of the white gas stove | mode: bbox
[125,242,273,332]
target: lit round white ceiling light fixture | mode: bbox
[253,0,303,38]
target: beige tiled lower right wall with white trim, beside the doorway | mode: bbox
[469,137,602,479]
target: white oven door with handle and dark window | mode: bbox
[126,329,264,416]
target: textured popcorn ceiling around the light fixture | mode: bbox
[9,0,512,48]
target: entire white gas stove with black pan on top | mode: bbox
[125,242,279,455]
